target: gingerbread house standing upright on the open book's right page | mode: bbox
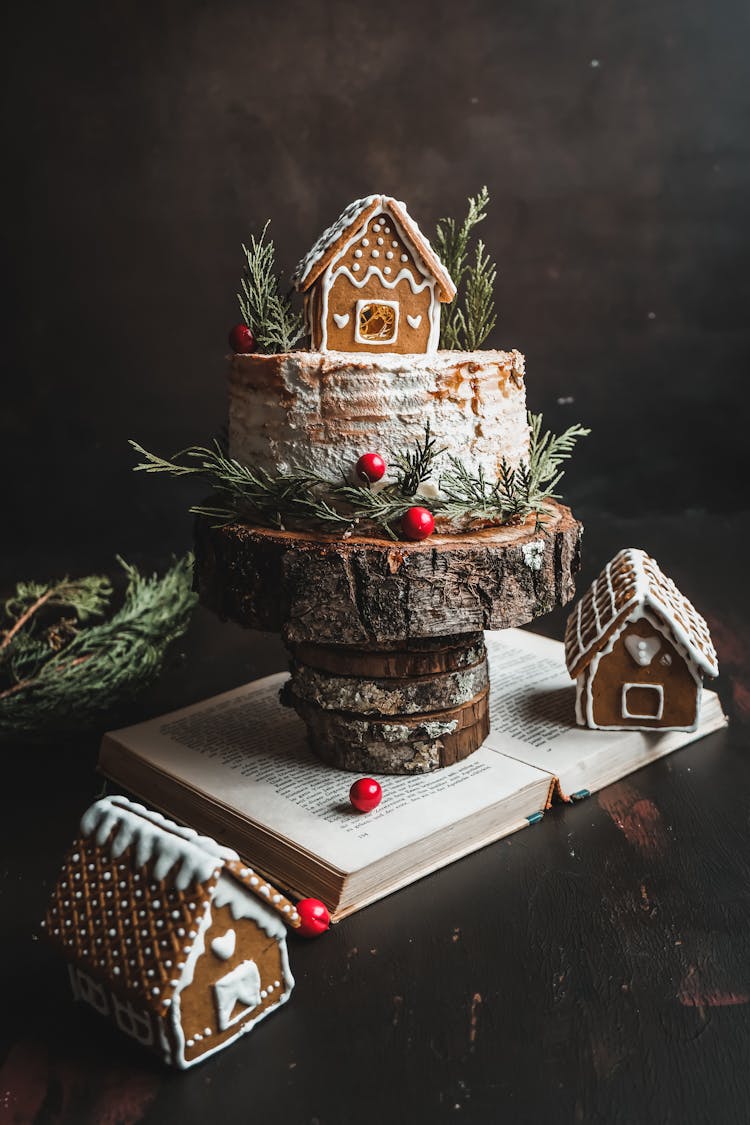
[566,548,719,730]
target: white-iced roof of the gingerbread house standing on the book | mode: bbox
[566,547,719,678]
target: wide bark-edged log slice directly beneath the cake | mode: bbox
[196,502,581,647]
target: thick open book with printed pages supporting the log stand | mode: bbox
[99,629,726,921]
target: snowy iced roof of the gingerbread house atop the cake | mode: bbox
[292,196,455,302]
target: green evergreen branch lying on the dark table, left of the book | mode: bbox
[0,556,197,739]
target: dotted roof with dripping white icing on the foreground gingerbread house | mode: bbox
[43,797,300,1016]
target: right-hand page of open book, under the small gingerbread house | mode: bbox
[485,629,726,797]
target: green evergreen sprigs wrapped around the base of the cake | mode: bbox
[130,414,589,539]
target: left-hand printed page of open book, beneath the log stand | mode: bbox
[102,674,551,872]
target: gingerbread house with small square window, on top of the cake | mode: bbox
[292,196,455,354]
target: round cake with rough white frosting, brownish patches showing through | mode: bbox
[229,351,528,484]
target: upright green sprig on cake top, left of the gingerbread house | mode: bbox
[237,219,305,353]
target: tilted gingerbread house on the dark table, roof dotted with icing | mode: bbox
[43,797,300,1069]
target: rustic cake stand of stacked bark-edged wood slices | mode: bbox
[196,503,582,774]
